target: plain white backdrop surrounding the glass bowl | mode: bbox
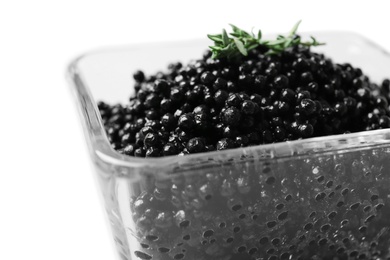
[0,0,390,260]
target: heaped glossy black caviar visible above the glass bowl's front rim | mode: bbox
[98,46,390,157]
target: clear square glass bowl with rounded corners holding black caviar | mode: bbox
[68,32,390,260]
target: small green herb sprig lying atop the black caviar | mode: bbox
[207,21,324,59]
